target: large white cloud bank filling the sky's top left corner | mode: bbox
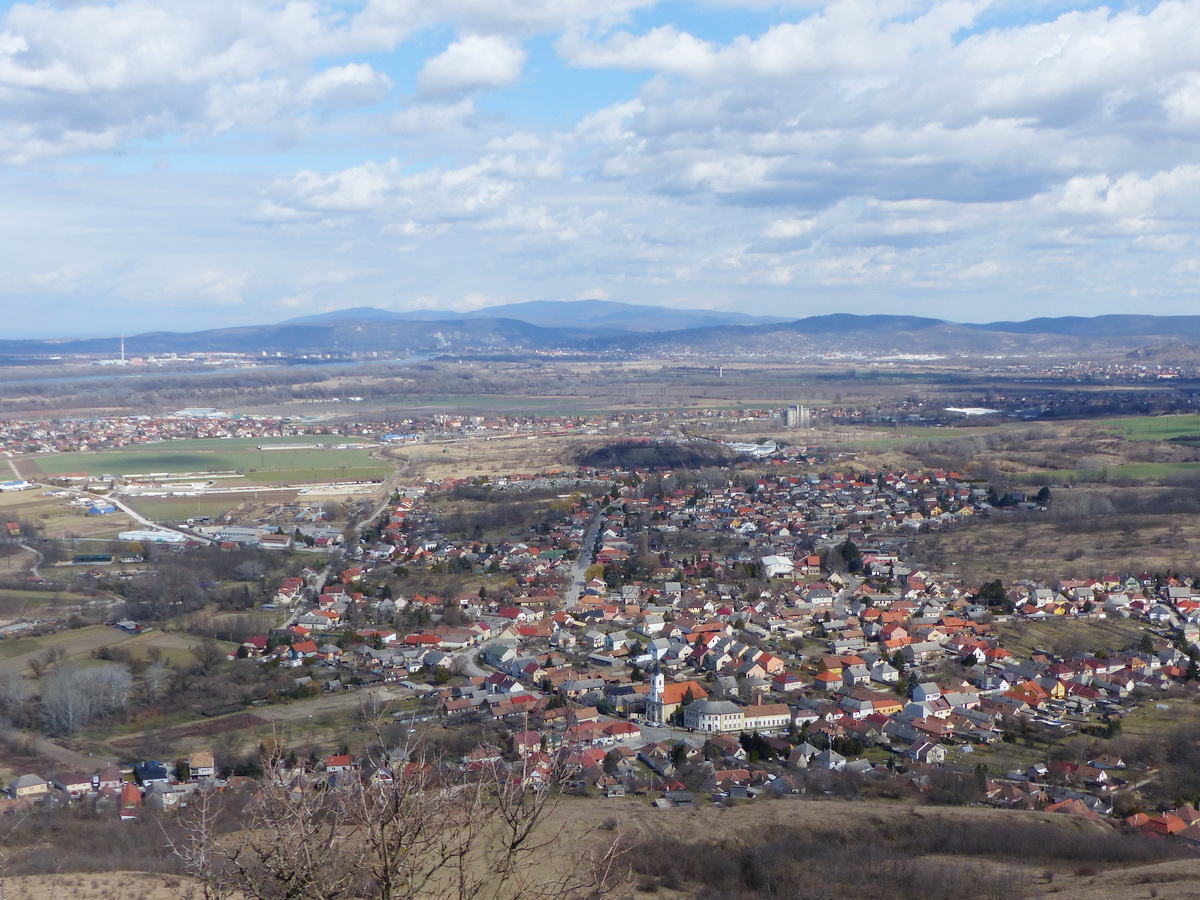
[0,0,390,162]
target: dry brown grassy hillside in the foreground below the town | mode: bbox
[2,798,1200,900]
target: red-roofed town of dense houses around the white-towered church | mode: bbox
[5,446,1200,868]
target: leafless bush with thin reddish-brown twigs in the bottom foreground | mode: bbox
[173,730,623,900]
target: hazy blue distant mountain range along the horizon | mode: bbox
[7,300,1200,359]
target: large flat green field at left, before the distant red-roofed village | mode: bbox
[18,436,392,484]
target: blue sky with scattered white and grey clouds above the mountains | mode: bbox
[0,0,1200,337]
